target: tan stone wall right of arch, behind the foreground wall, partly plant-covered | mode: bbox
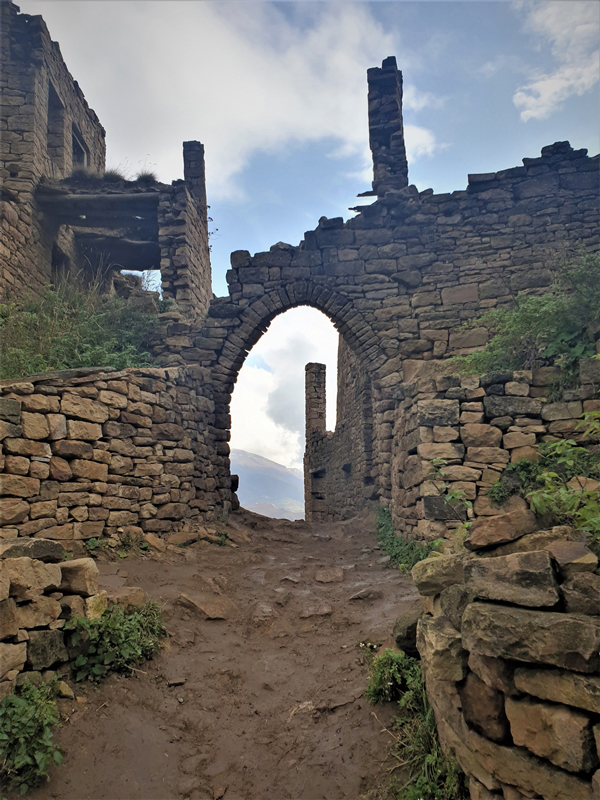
[391,358,600,540]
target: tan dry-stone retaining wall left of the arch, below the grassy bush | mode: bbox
[0,366,217,554]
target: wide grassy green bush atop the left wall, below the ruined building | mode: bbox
[0,280,156,378]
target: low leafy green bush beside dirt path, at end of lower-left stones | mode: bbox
[65,602,167,682]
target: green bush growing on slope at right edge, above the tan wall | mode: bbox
[455,251,600,385]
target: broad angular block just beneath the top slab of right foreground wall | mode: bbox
[464,551,559,608]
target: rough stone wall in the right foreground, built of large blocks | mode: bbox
[412,512,600,800]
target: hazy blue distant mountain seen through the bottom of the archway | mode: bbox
[230,449,304,519]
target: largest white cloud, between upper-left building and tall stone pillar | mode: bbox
[22,0,440,199]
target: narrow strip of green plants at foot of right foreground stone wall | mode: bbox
[367,650,468,800]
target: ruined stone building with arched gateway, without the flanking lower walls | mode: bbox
[0,0,599,535]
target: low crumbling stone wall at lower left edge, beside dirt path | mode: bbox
[0,539,108,700]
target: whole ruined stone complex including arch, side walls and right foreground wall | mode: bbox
[0,7,600,800]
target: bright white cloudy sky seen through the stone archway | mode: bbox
[231,307,338,468]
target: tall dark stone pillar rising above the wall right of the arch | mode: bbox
[367,56,408,197]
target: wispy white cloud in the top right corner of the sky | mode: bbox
[513,0,600,122]
